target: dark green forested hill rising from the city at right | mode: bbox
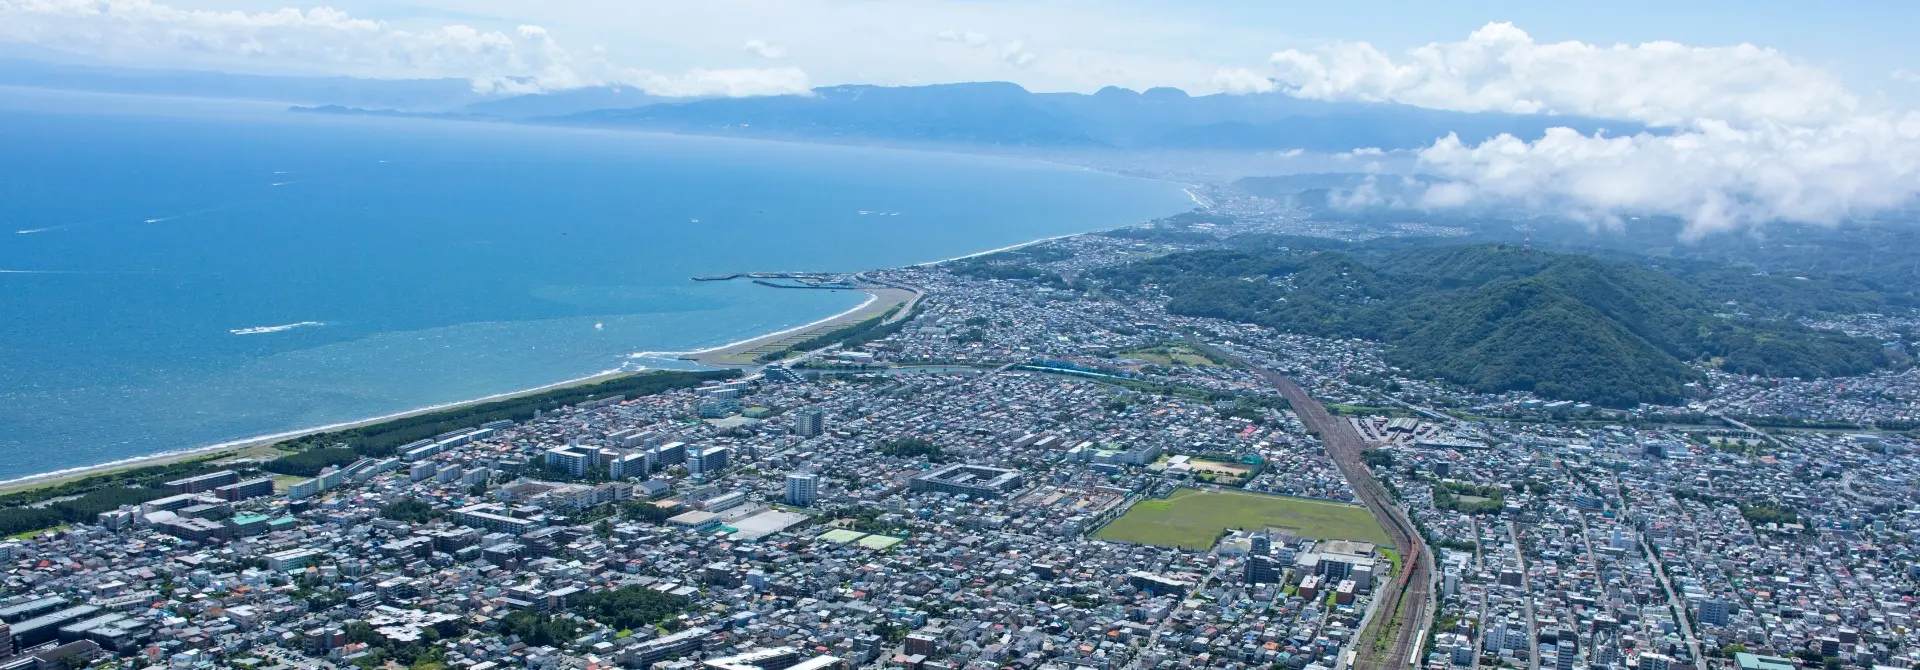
[1096,238,1893,407]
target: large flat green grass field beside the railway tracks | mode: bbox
[1094,488,1392,549]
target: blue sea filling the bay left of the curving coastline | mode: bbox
[0,88,1192,480]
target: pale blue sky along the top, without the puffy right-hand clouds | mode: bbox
[0,0,1920,104]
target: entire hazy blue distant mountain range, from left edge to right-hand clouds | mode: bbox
[0,58,1659,152]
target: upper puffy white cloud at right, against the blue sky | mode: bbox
[1271,23,1859,125]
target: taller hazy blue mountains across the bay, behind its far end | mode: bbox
[540,83,1644,152]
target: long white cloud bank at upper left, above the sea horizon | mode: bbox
[0,0,808,96]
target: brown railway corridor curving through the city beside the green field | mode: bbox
[1240,359,1434,670]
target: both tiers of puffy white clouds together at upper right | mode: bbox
[1271,23,1920,238]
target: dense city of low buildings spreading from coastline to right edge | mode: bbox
[0,194,1920,670]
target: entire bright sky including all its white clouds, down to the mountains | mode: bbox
[11,0,1920,234]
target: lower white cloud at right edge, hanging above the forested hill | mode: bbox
[1421,111,1920,238]
